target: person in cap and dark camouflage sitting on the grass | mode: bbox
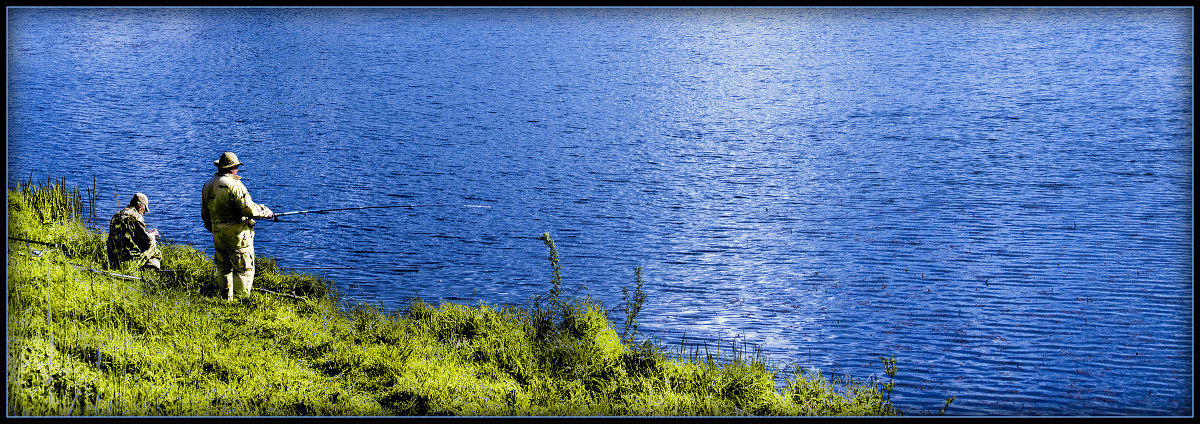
[104,193,162,269]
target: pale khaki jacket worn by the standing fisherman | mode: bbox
[200,173,271,249]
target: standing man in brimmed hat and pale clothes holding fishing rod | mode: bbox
[200,151,275,300]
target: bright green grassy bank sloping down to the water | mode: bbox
[6,184,898,416]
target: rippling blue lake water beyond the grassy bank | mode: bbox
[7,8,1194,416]
